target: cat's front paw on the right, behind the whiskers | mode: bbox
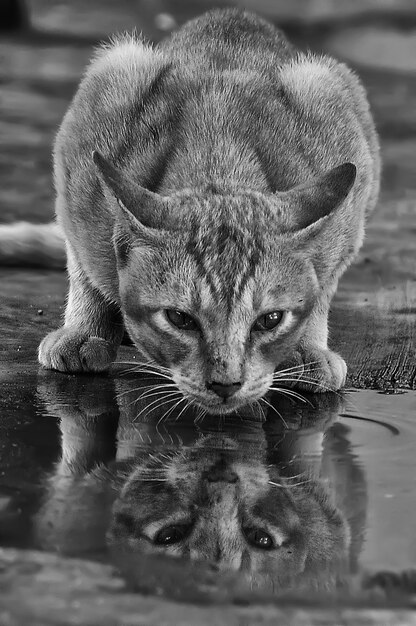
[274,347,347,392]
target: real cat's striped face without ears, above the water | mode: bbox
[119,196,319,413]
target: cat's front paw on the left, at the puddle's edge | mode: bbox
[38,327,117,373]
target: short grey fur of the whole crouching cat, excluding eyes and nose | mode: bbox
[35,9,380,412]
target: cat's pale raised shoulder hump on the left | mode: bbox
[55,33,171,161]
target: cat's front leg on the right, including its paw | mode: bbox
[278,289,347,392]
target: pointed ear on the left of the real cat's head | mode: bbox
[92,150,168,232]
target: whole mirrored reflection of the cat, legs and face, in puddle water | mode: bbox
[36,375,364,590]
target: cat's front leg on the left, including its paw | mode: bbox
[38,247,123,372]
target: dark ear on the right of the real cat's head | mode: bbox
[277,163,357,232]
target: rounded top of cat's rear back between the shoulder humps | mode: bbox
[159,8,296,74]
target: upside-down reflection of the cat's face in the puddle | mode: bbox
[108,434,349,588]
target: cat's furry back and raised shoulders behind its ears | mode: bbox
[55,9,380,207]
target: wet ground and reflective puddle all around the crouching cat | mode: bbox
[0,0,416,624]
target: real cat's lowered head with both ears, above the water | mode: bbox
[94,153,355,413]
